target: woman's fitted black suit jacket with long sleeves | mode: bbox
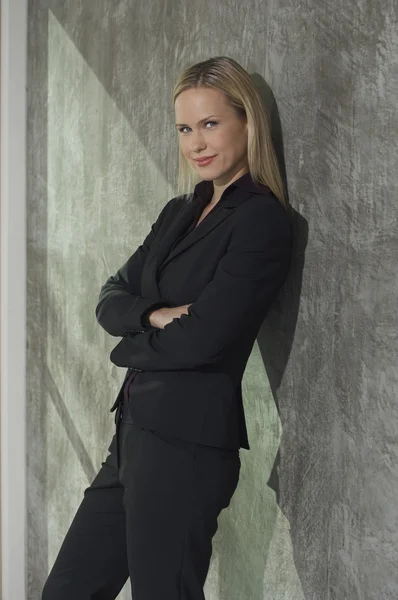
[96,173,293,449]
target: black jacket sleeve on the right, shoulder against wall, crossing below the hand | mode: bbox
[110,196,293,371]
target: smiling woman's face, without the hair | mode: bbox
[175,87,249,186]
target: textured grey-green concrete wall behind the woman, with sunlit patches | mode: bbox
[27,0,398,600]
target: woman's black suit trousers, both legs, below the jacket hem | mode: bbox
[42,392,240,600]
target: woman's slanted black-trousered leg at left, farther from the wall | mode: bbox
[42,435,129,600]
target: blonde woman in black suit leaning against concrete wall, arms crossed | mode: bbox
[42,57,292,600]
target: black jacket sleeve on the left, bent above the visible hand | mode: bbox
[95,200,176,336]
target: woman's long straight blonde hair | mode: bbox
[173,56,287,208]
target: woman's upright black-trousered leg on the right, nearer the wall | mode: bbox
[120,420,240,600]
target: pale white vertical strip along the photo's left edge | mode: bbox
[0,0,28,600]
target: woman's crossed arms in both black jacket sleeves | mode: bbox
[96,196,292,371]
